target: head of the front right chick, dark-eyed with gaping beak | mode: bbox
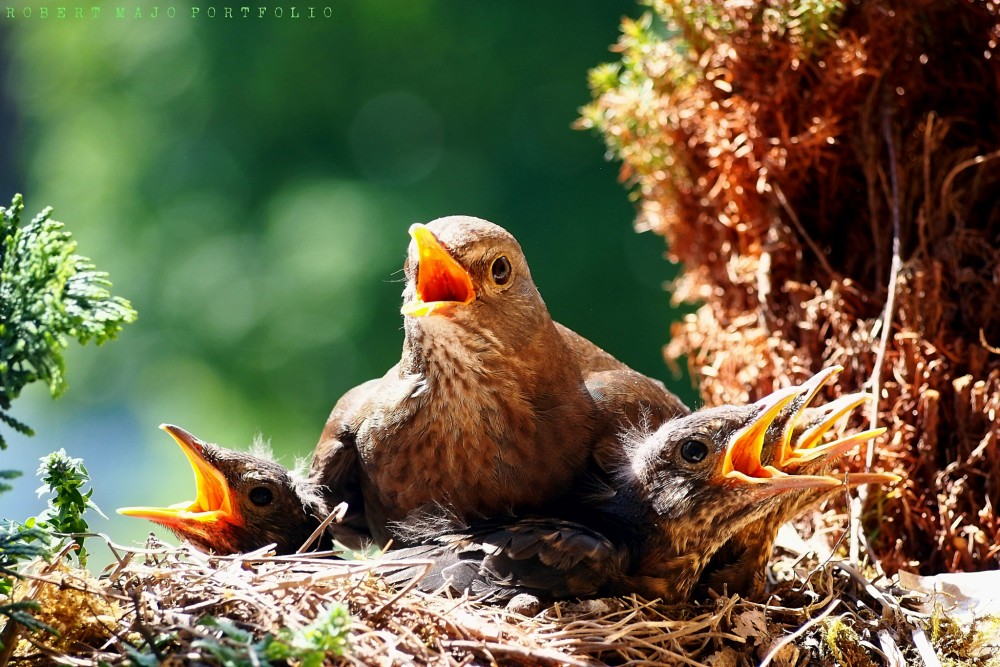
[623,376,899,520]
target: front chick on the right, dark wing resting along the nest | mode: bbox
[389,376,897,603]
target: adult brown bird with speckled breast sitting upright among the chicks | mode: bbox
[312,216,688,547]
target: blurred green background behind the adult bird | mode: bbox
[0,0,693,559]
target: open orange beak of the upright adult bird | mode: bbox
[401,222,476,317]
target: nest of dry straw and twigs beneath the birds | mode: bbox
[5,539,1000,667]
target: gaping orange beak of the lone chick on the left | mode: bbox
[118,424,243,534]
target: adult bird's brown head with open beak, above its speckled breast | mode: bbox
[402,216,548,332]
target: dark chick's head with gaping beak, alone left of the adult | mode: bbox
[118,424,328,554]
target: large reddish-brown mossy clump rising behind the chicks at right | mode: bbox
[581,0,1000,572]
